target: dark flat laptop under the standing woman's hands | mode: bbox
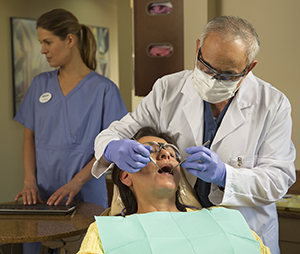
[0,203,77,215]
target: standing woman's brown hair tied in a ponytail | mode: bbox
[36,9,97,70]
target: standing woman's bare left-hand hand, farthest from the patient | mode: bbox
[15,183,43,205]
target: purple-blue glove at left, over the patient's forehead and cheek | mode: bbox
[103,139,152,173]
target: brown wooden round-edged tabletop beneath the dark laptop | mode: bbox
[0,202,105,243]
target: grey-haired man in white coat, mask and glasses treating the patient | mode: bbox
[92,16,296,254]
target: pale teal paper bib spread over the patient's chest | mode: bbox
[95,208,260,254]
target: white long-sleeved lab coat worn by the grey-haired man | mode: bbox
[93,71,296,254]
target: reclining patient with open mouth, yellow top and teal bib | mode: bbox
[78,127,270,254]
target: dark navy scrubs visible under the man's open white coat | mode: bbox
[194,97,234,207]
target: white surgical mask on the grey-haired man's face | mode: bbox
[193,67,241,103]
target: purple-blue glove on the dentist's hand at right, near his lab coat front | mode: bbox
[181,146,226,187]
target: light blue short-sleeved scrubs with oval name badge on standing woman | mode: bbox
[15,70,127,208]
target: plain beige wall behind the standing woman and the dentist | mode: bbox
[0,0,300,202]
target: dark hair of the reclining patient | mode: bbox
[112,127,184,215]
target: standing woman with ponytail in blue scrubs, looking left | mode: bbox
[15,9,127,211]
